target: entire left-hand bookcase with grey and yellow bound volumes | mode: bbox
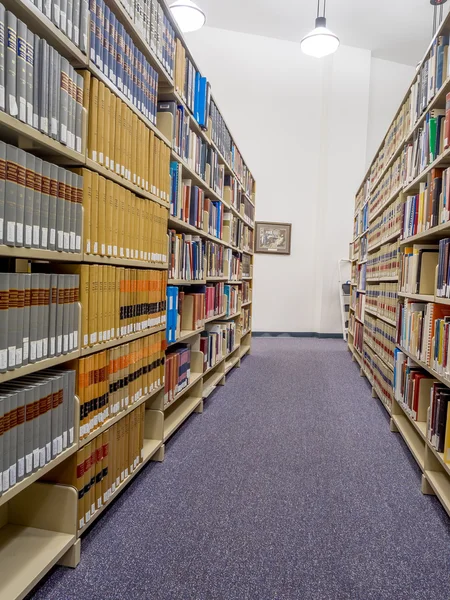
[0,0,256,600]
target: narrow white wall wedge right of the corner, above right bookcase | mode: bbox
[366,58,416,169]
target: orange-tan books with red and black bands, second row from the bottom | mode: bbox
[77,331,165,440]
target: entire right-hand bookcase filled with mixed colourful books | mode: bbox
[348,16,450,516]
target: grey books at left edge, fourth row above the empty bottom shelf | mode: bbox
[0,4,83,152]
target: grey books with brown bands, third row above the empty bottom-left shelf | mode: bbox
[0,146,83,253]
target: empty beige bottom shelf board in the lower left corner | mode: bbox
[0,524,76,600]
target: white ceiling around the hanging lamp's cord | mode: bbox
[196,0,450,65]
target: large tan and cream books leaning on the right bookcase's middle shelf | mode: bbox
[399,240,438,296]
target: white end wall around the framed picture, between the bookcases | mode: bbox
[187,27,414,333]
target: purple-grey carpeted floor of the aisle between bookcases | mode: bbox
[33,338,450,600]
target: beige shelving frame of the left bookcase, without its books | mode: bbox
[0,0,255,600]
